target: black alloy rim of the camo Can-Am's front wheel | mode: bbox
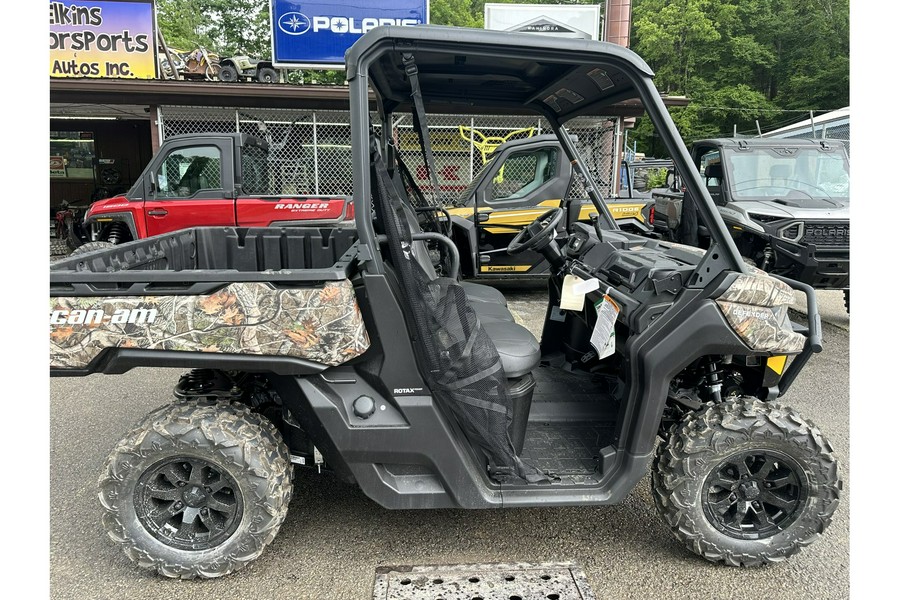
[702,450,809,540]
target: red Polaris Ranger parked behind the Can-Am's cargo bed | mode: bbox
[70,133,354,251]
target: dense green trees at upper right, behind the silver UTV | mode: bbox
[632,0,850,154]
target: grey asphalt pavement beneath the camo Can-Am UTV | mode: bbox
[49,290,852,600]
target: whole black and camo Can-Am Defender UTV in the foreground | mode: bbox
[50,26,841,578]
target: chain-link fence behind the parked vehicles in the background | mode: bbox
[160,106,619,203]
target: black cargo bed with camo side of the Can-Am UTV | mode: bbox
[50,227,369,375]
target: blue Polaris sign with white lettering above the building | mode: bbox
[271,0,428,69]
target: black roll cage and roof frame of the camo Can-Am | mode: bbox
[346,25,746,288]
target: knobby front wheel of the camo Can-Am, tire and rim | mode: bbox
[652,397,841,567]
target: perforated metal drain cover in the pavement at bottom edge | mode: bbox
[373,562,596,600]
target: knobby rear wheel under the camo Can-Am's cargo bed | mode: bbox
[99,400,292,579]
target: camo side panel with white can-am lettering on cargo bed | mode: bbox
[50,280,369,369]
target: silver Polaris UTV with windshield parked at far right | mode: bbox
[653,138,850,312]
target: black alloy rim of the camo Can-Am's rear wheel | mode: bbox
[134,456,243,550]
